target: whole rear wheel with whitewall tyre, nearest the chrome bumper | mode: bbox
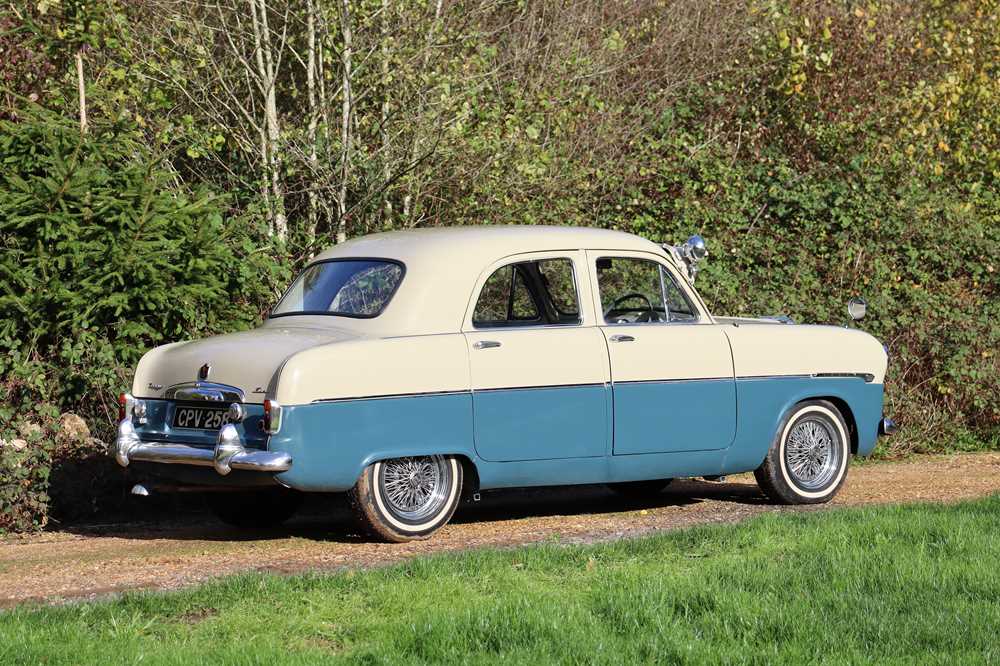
[348,455,462,543]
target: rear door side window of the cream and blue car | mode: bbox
[472,259,580,328]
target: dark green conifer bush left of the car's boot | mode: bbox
[0,108,286,525]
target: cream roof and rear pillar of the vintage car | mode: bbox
[267,225,670,337]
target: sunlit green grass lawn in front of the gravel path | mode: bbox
[0,497,1000,664]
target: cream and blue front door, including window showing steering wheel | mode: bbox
[588,252,736,455]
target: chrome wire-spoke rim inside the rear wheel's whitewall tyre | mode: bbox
[376,456,453,524]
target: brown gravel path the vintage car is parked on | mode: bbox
[0,453,1000,607]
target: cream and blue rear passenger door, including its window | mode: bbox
[465,252,611,462]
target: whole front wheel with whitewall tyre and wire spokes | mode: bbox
[754,400,851,504]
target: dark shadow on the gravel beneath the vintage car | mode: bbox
[62,479,768,543]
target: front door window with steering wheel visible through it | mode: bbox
[597,257,697,324]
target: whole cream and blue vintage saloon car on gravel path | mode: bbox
[114,226,895,541]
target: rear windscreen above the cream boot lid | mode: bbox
[271,259,404,317]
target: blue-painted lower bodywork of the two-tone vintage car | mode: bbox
[138,376,883,492]
